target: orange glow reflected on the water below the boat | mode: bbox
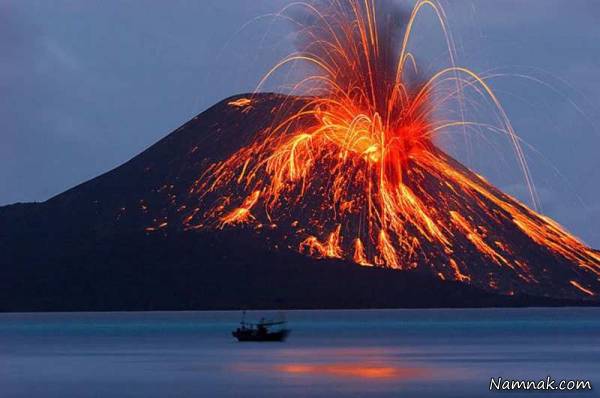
[275,363,426,379]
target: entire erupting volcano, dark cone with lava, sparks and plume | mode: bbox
[0,0,600,311]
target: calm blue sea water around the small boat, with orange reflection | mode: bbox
[0,309,600,398]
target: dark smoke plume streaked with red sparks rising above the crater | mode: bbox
[288,0,426,113]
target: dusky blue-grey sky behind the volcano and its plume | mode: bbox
[0,0,600,248]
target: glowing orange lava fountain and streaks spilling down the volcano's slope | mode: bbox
[184,0,600,297]
